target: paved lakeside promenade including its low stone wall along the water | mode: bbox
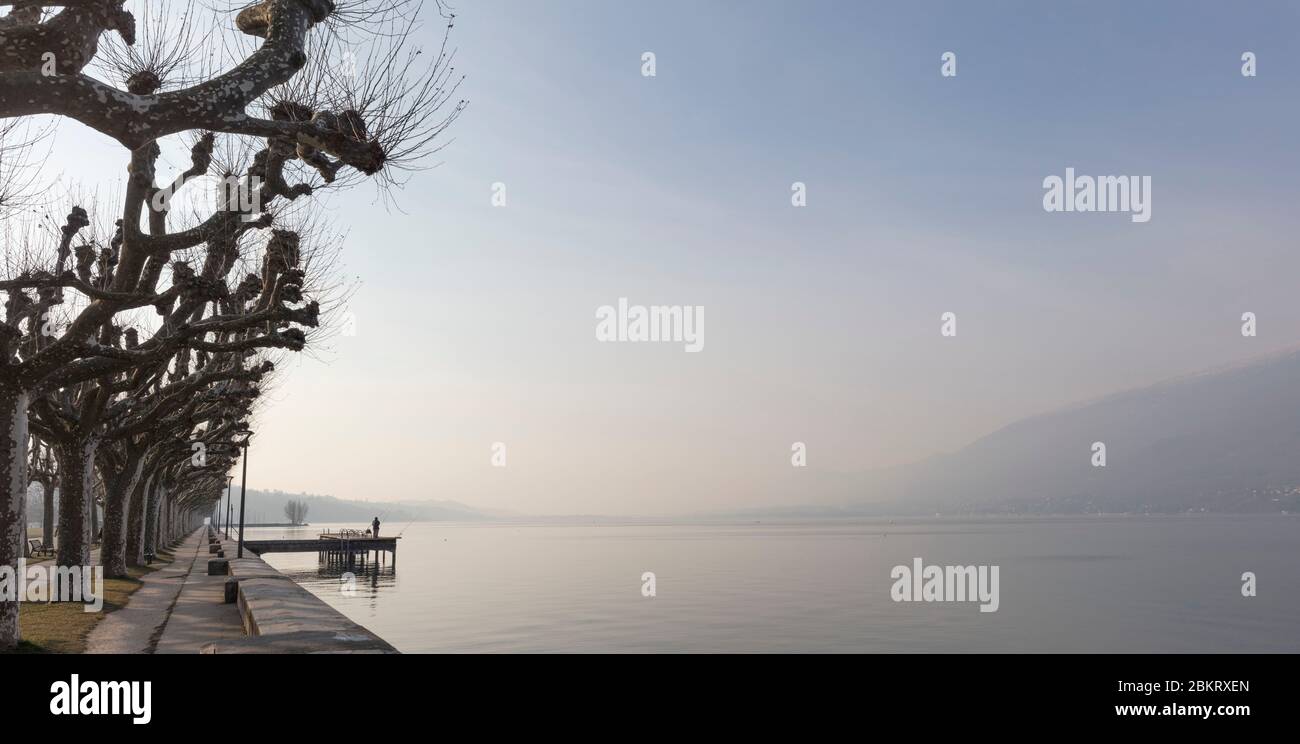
[86,527,397,654]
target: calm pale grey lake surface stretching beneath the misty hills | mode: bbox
[248,515,1300,652]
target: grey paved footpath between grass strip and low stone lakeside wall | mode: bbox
[86,527,244,653]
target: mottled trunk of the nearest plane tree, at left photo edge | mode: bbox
[0,386,27,650]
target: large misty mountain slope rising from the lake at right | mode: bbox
[862,350,1300,512]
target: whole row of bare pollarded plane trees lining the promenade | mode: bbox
[0,0,464,650]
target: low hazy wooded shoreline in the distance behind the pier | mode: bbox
[222,484,491,525]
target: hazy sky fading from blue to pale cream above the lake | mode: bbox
[25,0,1300,515]
